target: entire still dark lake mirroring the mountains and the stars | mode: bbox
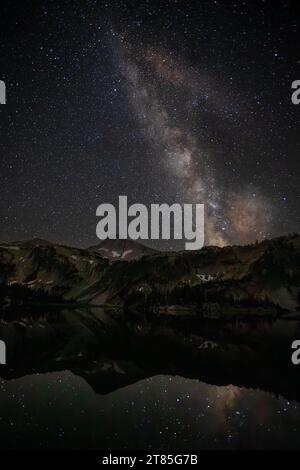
[0,309,300,450]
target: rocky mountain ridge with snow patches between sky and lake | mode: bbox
[0,235,300,318]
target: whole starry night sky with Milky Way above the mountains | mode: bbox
[0,0,300,249]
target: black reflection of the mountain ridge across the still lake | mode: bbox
[0,308,300,401]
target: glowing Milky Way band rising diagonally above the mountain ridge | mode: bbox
[115,38,271,246]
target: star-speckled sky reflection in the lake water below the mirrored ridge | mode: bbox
[0,371,300,450]
